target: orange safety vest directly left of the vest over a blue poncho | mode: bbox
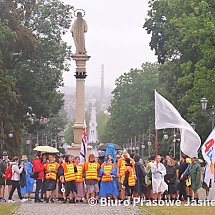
[85,162,99,180]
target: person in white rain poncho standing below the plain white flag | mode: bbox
[151,155,168,200]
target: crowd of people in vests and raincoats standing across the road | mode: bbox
[0,149,207,203]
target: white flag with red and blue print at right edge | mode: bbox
[202,128,215,186]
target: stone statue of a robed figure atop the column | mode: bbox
[71,12,88,55]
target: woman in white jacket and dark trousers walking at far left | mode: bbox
[8,156,27,203]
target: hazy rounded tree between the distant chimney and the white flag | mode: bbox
[105,63,162,145]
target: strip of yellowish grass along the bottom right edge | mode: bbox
[140,206,215,215]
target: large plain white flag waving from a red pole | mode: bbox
[155,91,201,157]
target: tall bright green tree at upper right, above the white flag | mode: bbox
[144,0,215,136]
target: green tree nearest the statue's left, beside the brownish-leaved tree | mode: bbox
[13,0,72,119]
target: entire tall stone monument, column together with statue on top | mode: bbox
[69,10,90,156]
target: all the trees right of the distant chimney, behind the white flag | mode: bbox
[101,0,215,158]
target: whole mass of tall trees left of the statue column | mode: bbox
[0,0,73,155]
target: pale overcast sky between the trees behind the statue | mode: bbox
[63,0,156,88]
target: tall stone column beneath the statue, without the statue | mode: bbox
[69,54,90,156]
